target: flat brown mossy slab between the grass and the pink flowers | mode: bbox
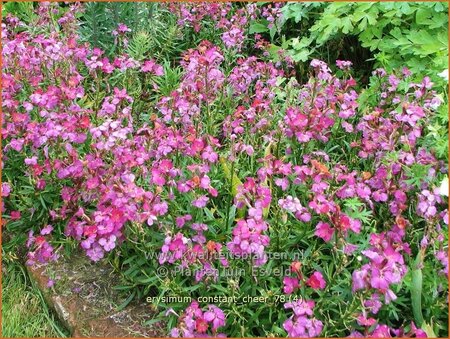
[27,253,166,338]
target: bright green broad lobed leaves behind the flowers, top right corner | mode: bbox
[283,2,448,85]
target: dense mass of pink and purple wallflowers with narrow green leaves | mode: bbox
[2,3,448,337]
